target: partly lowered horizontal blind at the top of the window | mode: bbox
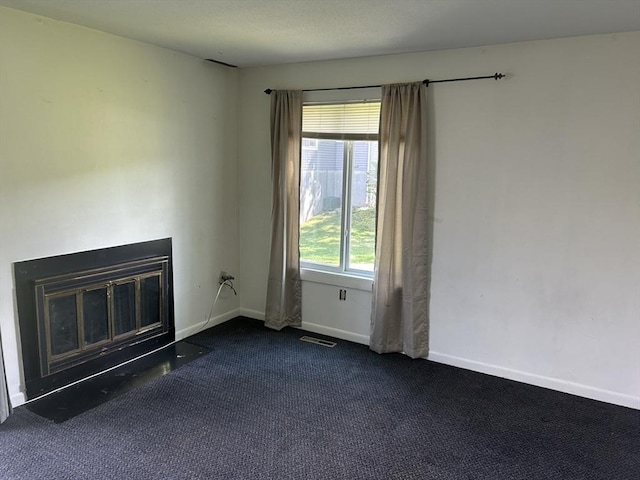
[302,102,380,140]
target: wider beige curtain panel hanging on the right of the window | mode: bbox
[370,82,430,358]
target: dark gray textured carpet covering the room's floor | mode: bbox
[0,319,640,480]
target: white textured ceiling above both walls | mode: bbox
[0,0,640,67]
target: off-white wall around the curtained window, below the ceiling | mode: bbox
[239,32,640,408]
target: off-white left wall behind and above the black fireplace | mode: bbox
[0,7,239,405]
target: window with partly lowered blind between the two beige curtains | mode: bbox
[300,101,380,276]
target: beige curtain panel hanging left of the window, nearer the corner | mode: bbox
[265,90,302,330]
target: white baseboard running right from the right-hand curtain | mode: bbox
[428,351,640,410]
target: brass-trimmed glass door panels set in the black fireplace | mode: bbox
[36,257,167,376]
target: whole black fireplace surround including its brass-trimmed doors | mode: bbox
[13,238,175,399]
